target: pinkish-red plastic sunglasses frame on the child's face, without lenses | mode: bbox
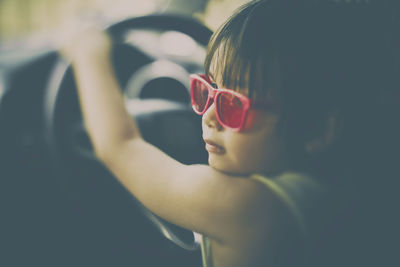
[190,74,251,132]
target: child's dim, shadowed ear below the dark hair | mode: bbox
[305,112,343,154]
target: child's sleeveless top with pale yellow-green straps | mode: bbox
[201,172,326,267]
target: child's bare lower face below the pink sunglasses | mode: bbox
[202,79,286,175]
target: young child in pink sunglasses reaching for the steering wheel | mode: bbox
[63,0,393,267]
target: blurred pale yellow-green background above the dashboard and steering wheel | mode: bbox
[0,0,248,50]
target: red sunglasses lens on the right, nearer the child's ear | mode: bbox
[216,92,244,128]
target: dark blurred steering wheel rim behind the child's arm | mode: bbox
[44,14,212,253]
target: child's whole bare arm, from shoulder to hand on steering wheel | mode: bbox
[63,31,290,247]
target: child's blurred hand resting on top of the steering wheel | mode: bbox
[60,22,112,64]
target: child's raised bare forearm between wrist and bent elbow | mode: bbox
[72,53,140,157]
